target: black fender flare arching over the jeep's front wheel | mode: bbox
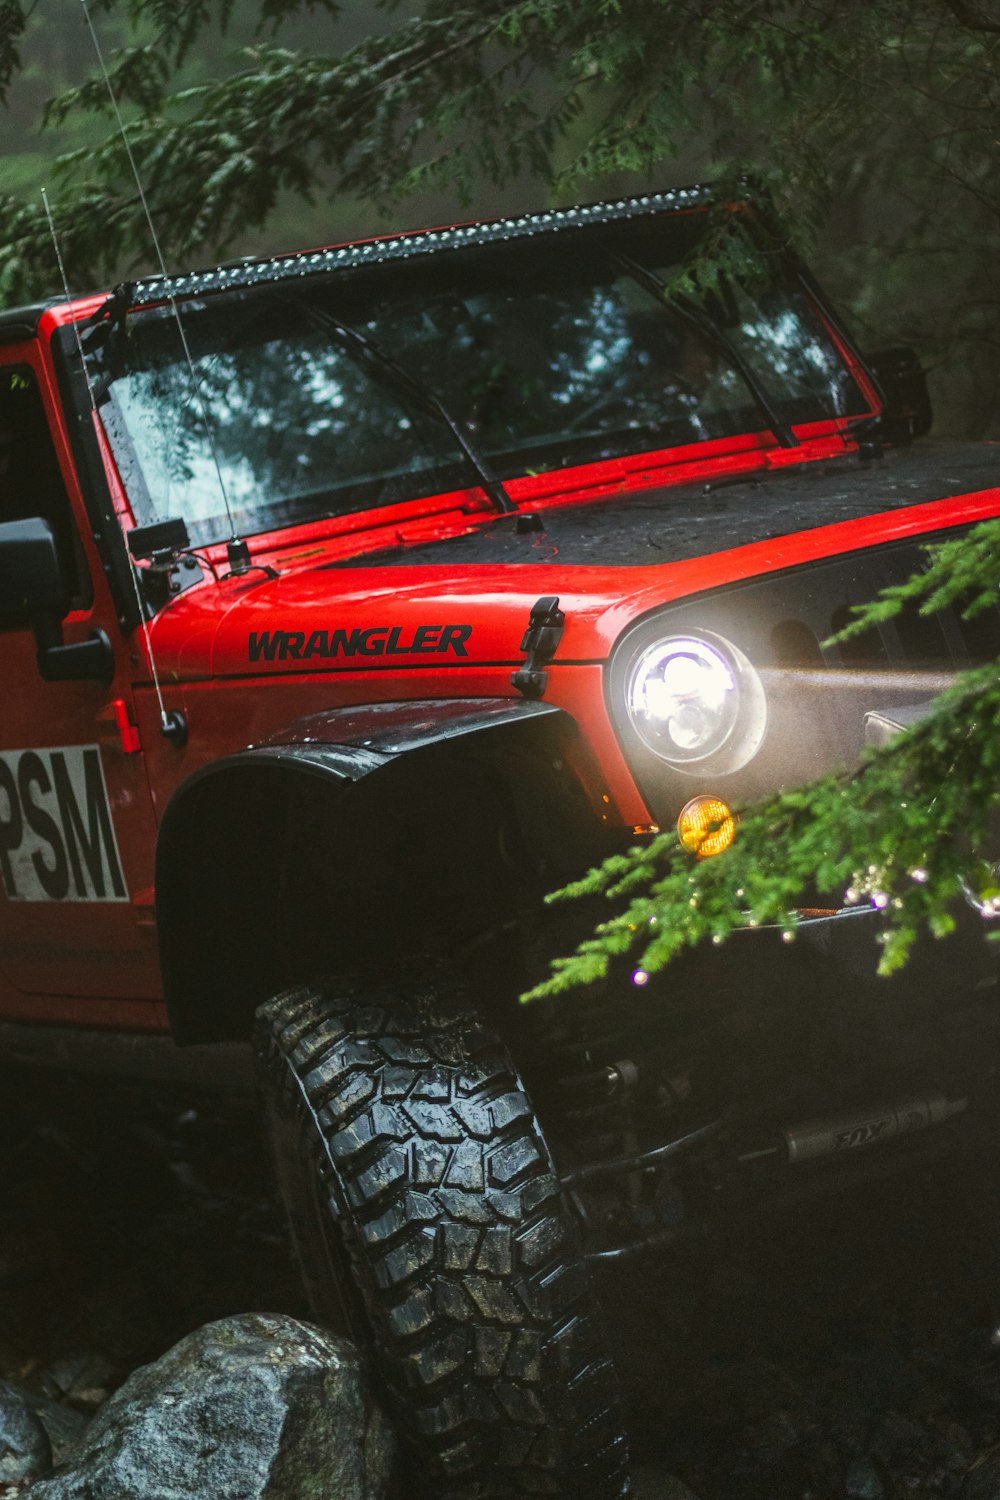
[156,698,579,1044]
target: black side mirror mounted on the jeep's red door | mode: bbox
[0,516,114,683]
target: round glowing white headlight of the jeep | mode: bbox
[625,630,768,773]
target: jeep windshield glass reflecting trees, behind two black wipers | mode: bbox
[103,213,867,543]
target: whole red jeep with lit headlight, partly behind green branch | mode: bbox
[0,188,1000,1500]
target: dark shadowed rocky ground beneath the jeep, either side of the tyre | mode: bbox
[0,1077,1000,1500]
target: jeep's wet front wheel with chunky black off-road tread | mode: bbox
[256,977,628,1500]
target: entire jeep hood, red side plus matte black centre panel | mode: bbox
[153,444,1000,677]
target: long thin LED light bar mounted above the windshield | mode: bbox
[120,186,718,308]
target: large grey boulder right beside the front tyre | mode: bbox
[31,1313,396,1500]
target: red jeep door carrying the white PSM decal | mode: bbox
[0,339,160,1026]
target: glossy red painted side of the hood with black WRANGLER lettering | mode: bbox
[140,488,1000,678]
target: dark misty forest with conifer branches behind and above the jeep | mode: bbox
[0,0,1000,437]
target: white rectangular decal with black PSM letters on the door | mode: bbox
[0,746,129,902]
